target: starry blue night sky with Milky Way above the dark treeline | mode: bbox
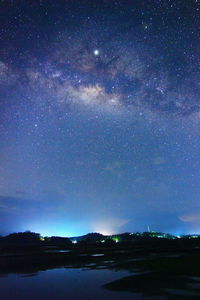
[0,0,200,236]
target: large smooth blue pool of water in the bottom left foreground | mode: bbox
[0,268,149,300]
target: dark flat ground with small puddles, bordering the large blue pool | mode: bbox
[0,240,200,299]
